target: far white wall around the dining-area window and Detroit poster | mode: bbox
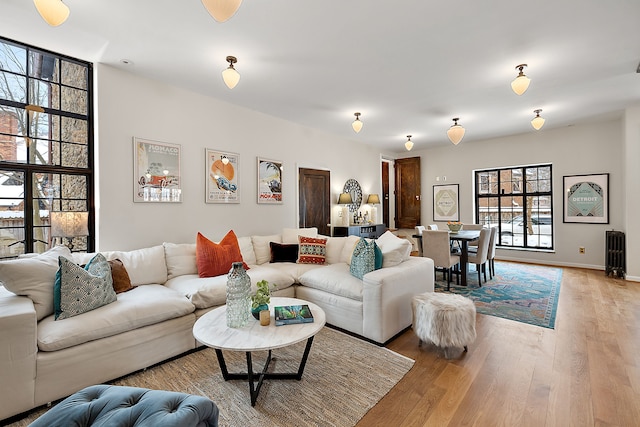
[404,120,624,268]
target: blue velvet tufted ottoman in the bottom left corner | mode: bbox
[30,385,218,427]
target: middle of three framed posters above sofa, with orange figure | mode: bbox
[205,148,240,203]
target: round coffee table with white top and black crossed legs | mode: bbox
[193,297,326,406]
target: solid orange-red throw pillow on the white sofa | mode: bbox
[196,230,249,277]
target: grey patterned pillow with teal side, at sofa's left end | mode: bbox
[53,254,117,320]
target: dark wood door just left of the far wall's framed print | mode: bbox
[395,157,421,228]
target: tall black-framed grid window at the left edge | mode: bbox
[0,38,94,258]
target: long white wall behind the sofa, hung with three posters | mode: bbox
[96,64,381,250]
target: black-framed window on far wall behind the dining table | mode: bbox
[475,165,553,249]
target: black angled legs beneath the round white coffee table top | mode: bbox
[215,337,313,406]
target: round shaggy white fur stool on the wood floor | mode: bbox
[413,292,476,357]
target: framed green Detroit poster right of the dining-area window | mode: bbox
[562,173,609,224]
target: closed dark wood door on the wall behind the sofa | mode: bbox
[298,168,331,236]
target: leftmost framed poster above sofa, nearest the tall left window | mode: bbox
[133,137,182,203]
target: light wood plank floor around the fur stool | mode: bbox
[358,268,640,427]
